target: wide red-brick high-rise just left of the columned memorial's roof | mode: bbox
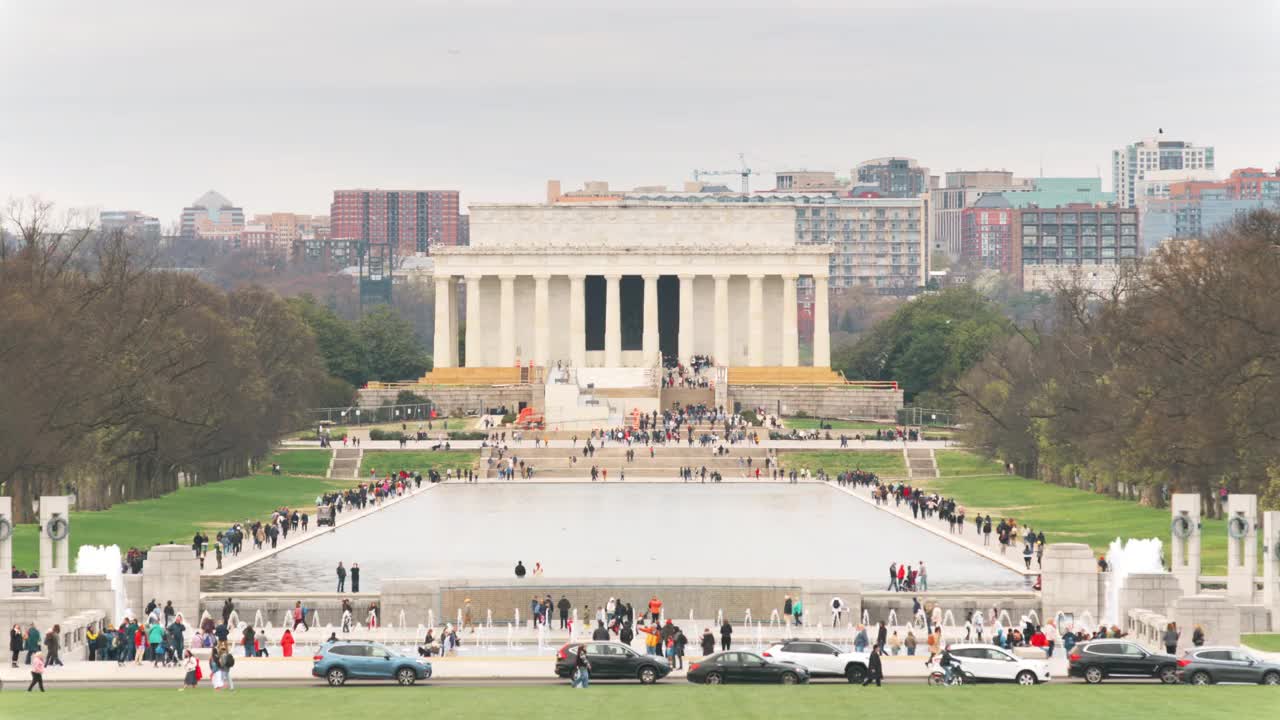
[329,190,458,256]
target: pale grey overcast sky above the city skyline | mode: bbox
[0,0,1280,223]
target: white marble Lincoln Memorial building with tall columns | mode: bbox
[434,204,831,368]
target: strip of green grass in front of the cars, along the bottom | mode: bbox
[0,679,1259,720]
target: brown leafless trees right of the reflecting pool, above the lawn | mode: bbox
[955,210,1280,511]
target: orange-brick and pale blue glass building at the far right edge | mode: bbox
[1142,168,1280,252]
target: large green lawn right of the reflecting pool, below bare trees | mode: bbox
[927,471,1226,575]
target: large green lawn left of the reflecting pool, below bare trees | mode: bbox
[13,475,352,570]
